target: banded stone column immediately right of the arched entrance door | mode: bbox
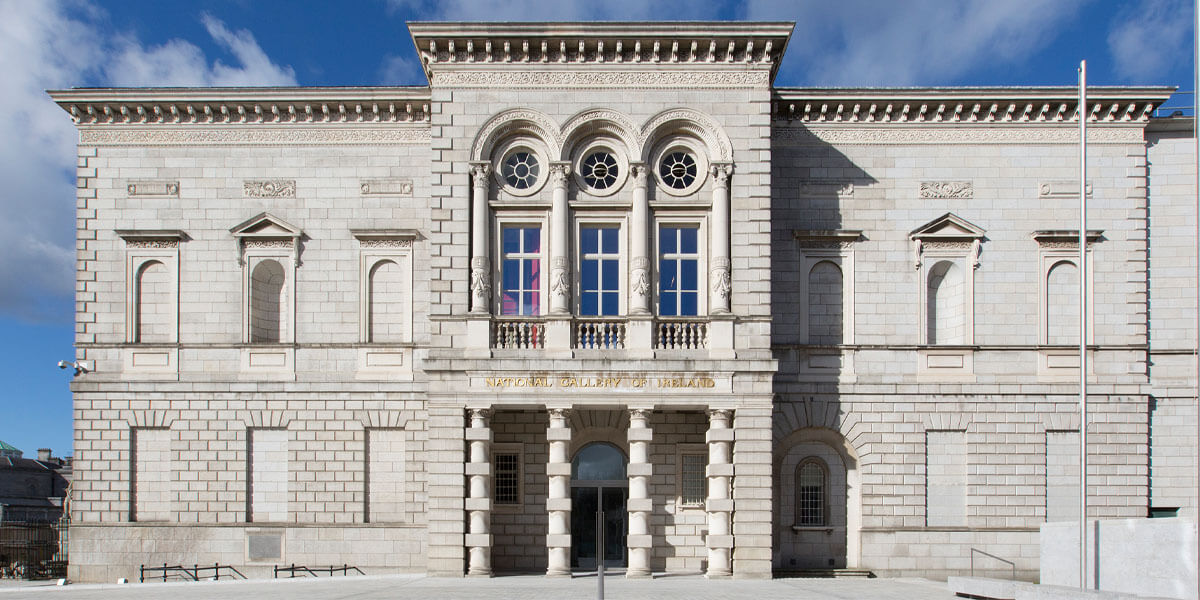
[625,408,654,578]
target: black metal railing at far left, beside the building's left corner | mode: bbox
[0,520,68,580]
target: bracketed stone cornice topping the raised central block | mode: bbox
[408,22,794,85]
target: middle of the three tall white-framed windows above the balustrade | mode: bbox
[578,223,623,317]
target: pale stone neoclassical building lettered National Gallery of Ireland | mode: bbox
[52,23,1196,581]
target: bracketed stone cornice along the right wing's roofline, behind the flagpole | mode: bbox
[774,88,1175,124]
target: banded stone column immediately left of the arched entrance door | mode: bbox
[546,408,571,577]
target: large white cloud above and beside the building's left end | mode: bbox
[0,0,295,322]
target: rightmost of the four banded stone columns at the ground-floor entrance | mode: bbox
[704,409,733,578]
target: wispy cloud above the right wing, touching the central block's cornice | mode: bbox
[746,0,1084,86]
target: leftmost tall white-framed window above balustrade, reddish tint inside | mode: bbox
[499,223,546,316]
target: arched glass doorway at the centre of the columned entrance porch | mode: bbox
[571,442,629,569]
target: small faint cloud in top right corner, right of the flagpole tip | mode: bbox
[1109,0,1193,82]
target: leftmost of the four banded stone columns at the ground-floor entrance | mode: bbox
[466,408,492,577]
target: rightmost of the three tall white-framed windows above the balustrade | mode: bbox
[658,222,706,317]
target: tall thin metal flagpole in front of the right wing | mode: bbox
[1079,60,1087,589]
